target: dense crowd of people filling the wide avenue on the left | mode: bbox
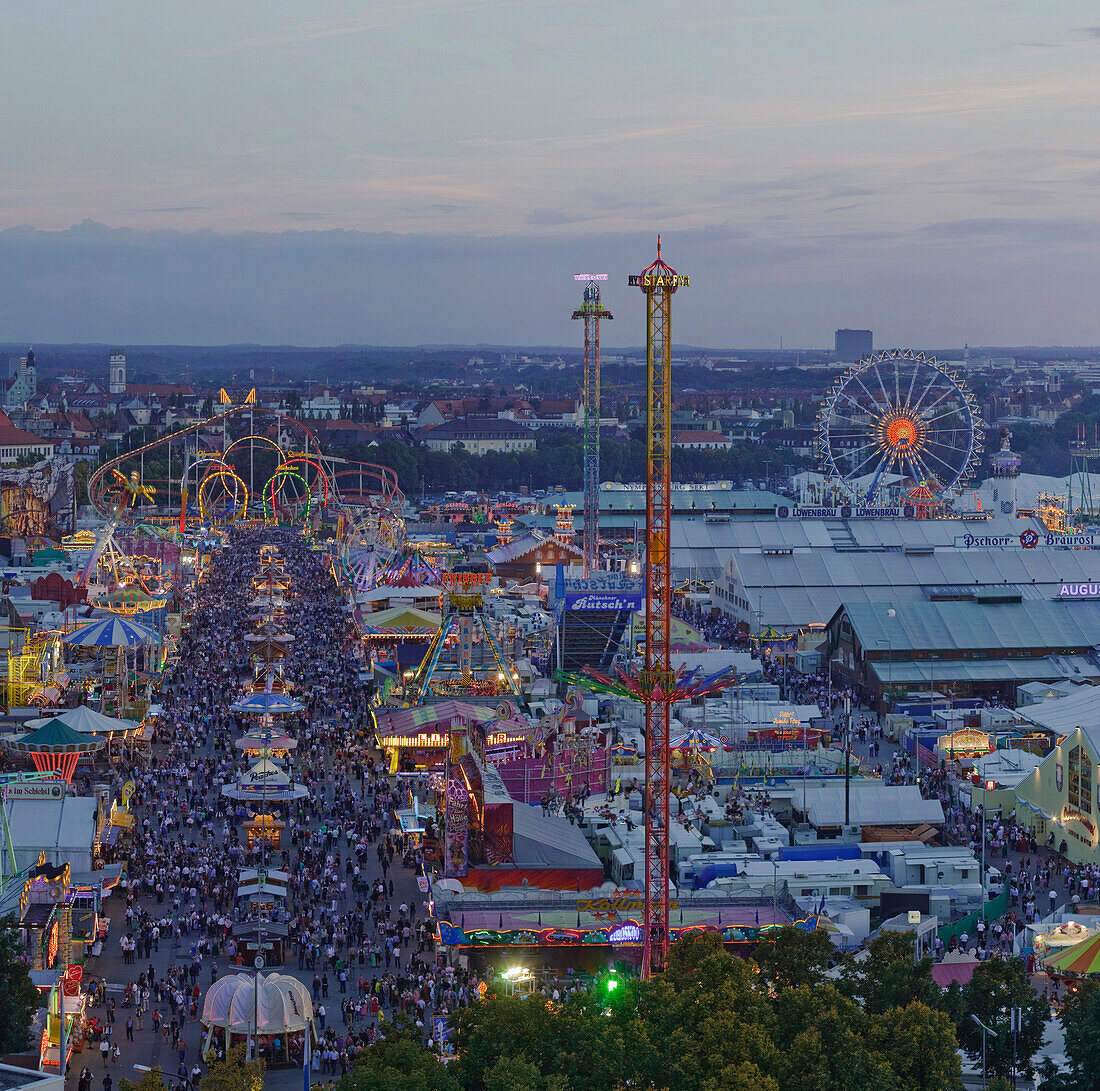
[69,530,495,1086]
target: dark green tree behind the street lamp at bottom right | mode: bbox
[943,959,1049,1076]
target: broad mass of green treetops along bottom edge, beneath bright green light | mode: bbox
[338,933,961,1091]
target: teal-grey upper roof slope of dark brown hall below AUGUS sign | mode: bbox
[845,599,1100,651]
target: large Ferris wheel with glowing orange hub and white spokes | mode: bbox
[817,349,981,504]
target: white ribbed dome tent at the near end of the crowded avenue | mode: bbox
[202,973,316,1065]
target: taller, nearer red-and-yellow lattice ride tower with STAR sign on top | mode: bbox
[628,235,690,979]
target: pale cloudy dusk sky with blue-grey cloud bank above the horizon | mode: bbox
[0,0,1100,348]
